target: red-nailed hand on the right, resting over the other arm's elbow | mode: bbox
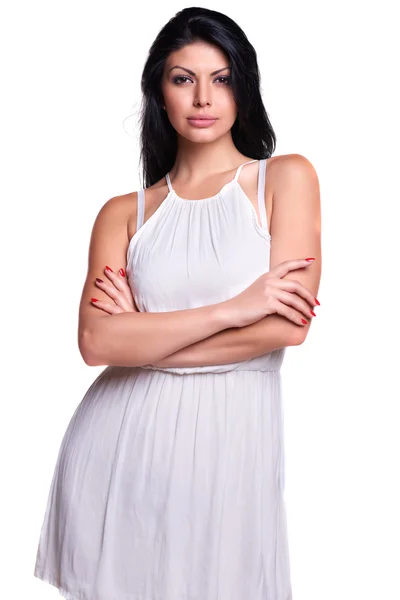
[225,258,316,327]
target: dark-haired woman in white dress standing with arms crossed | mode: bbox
[35,8,321,600]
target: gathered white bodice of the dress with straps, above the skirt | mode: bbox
[126,159,285,374]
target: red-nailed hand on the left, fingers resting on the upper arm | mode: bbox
[92,266,139,315]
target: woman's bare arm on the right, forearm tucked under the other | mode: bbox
[150,154,321,367]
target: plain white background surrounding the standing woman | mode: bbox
[0,0,400,600]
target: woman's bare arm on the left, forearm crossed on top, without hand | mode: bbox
[78,193,234,367]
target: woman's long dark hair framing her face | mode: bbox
[139,7,276,188]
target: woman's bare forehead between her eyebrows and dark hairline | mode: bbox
[166,41,229,68]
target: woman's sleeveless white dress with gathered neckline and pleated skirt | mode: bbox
[34,159,292,600]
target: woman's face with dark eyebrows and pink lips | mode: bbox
[161,42,237,142]
